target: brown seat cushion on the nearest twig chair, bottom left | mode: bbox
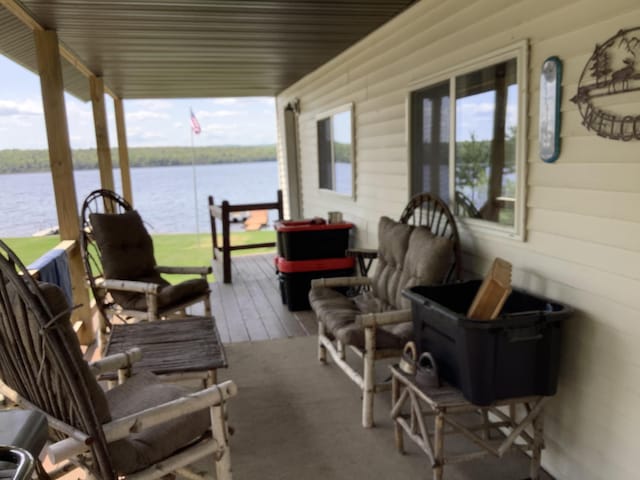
[106,372,211,474]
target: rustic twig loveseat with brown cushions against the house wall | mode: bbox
[309,193,461,427]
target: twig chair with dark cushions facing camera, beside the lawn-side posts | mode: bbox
[80,190,211,344]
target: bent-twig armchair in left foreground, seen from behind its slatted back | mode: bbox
[0,241,236,480]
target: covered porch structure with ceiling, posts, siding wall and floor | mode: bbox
[0,0,640,479]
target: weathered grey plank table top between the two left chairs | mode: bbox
[105,317,227,375]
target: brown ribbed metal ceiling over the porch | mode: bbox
[0,0,414,100]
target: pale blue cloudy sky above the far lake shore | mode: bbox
[0,55,276,150]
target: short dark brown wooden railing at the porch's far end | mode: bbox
[209,190,283,283]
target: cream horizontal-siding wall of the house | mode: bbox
[277,0,640,479]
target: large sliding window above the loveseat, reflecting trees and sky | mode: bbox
[409,46,526,236]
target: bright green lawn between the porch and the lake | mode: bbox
[3,230,276,283]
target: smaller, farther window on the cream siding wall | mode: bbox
[317,105,354,196]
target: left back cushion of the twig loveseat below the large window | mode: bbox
[371,217,414,308]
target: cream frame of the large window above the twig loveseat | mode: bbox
[405,40,529,241]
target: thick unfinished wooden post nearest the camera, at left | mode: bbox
[34,30,94,345]
